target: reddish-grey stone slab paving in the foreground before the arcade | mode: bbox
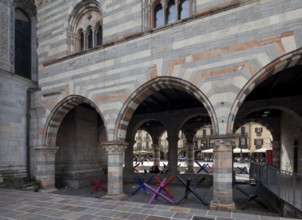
[0,188,298,220]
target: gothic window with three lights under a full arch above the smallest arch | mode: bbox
[68,0,103,53]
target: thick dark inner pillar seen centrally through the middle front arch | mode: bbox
[167,137,179,174]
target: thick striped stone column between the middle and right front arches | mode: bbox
[210,135,236,211]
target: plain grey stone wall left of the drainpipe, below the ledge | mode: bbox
[0,69,36,181]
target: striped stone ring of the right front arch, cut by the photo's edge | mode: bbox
[226,48,302,134]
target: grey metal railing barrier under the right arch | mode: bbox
[250,163,302,211]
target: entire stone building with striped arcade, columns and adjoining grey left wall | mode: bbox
[0,0,302,210]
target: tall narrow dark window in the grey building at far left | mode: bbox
[15,8,31,79]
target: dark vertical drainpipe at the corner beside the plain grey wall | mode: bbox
[26,87,41,182]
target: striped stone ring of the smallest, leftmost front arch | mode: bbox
[42,95,107,147]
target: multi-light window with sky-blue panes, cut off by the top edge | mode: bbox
[149,0,192,28]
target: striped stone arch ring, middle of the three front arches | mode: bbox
[114,76,218,140]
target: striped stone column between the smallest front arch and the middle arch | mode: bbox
[102,141,127,200]
